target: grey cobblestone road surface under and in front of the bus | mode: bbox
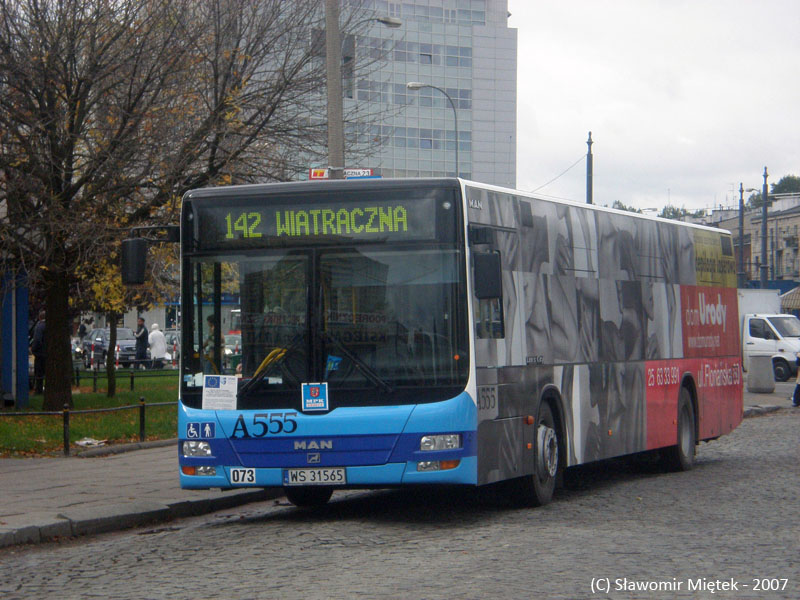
[0,408,800,600]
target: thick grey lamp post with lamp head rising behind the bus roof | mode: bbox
[325,0,403,179]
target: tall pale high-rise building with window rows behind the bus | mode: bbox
[343,0,517,187]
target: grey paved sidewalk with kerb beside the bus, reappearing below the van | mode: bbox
[0,381,800,547]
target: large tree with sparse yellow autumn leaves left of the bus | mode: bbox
[0,0,338,409]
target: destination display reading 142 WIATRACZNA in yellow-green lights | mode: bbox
[194,196,444,250]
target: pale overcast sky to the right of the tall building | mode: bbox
[508,0,800,210]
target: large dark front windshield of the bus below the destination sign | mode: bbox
[183,245,468,408]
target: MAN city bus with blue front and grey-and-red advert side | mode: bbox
[178,179,741,505]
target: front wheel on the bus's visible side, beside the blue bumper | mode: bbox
[514,402,560,506]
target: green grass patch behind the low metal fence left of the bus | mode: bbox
[0,370,178,457]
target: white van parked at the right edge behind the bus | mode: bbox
[742,314,800,381]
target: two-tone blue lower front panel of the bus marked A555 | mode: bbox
[178,393,477,489]
